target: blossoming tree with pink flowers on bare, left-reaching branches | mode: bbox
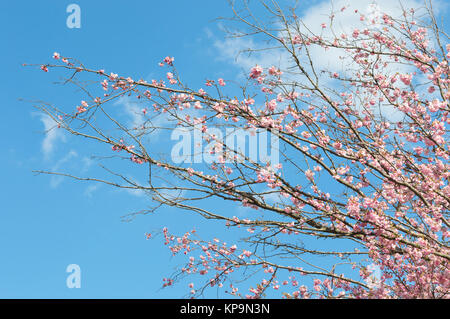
[33,4,450,298]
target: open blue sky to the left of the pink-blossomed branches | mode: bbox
[0,0,448,298]
